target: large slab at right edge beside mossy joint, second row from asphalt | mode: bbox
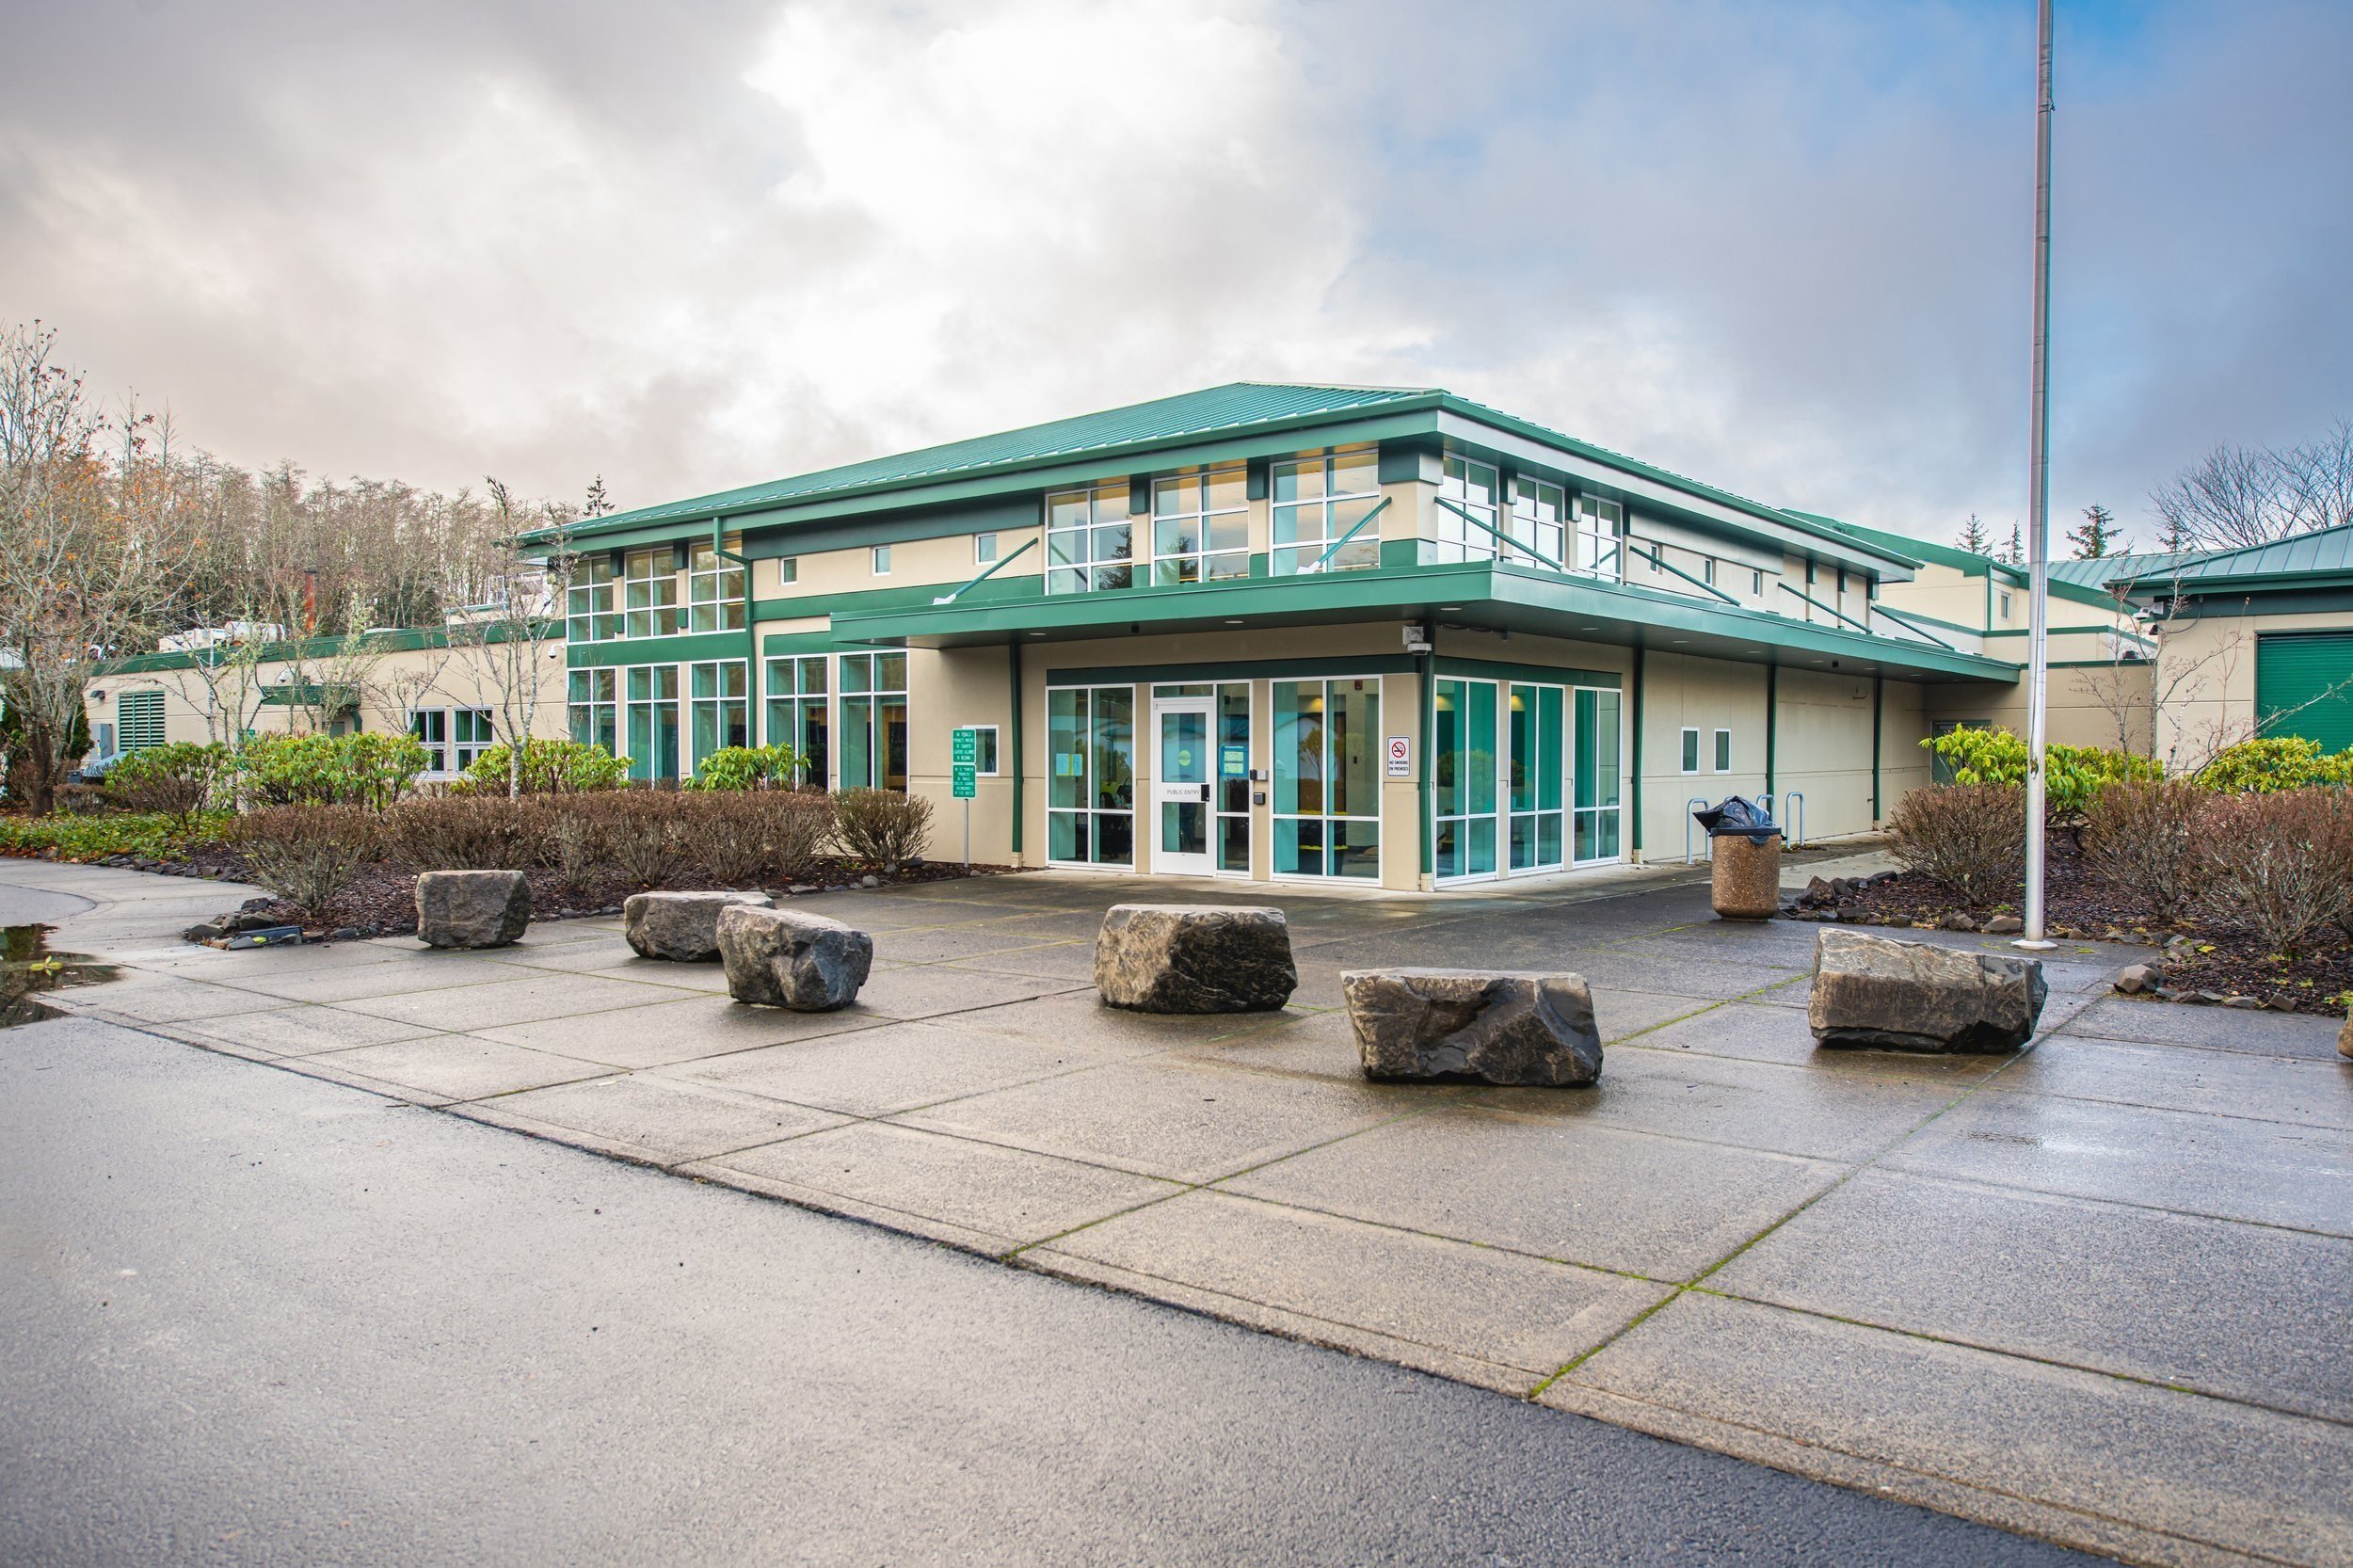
[1708,1170,2353,1424]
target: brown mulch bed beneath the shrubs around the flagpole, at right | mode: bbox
[1784,834,2353,1017]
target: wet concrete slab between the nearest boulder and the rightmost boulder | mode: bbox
[1473,1046,1962,1160]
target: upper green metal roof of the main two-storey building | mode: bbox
[522,381,1918,565]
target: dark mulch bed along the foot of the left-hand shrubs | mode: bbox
[71,845,1015,942]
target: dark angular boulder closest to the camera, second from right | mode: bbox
[1339,970,1603,1088]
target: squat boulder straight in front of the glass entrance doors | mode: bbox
[1095,904,1299,1013]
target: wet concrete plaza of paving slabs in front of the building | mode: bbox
[18,864,2353,1563]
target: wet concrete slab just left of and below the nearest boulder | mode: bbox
[899,1057,1454,1182]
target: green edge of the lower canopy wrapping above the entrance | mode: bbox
[833,560,2019,685]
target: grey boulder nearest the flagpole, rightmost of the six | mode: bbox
[1805,930,2050,1052]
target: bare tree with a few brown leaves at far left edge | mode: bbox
[0,323,191,812]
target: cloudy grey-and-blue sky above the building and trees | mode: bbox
[0,0,2353,548]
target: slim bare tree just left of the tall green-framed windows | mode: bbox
[450,480,574,796]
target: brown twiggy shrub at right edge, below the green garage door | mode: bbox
[2201,789,2353,958]
